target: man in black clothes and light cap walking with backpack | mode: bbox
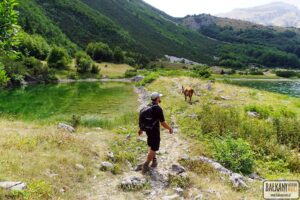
[139,92,173,174]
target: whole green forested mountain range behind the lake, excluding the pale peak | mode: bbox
[19,0,300,68]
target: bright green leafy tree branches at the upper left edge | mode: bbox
[0,0,19,54]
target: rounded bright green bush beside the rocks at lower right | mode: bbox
[214,136,254,174]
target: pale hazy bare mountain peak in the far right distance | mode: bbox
[217,2,300,28]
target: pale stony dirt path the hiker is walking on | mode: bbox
[84,88,188,200]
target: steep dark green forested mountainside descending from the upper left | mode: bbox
[19,0,218,63]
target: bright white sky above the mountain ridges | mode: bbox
[144,0,300,17]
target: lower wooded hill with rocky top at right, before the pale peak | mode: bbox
[179,14,300,68]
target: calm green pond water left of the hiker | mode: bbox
[0,82,137,122]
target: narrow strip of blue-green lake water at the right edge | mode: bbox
[230,79,300,97]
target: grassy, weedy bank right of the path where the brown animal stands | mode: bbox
[148,77,300,178]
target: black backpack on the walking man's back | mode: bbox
[139,104,159,131]
